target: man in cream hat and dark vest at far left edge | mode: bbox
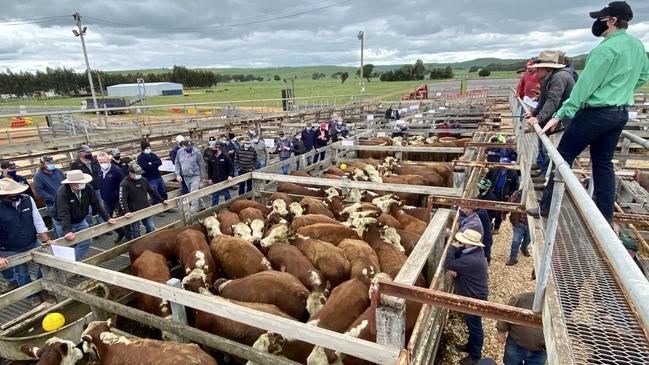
[0,179,55,307]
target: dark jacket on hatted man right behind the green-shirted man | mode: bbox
[532,68,575,126]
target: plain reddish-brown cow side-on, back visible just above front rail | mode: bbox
[215,271,311,320]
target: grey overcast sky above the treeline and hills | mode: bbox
[0,0,649,71]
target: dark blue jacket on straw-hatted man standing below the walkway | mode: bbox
[444,245,489,300]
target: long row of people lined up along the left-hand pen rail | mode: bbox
[0,115,349,306]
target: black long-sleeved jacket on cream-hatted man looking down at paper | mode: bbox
[54,184,110,234]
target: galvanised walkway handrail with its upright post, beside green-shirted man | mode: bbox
[512,90,649,328]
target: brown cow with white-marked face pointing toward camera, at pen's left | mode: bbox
[176,230,218,293]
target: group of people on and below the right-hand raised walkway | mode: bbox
[445,1,649,365]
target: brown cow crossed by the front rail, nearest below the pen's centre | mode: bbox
[194,300,294,346]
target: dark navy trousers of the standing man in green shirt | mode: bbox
[540,108,629,222]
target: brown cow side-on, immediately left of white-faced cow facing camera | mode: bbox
[128,224,207,262]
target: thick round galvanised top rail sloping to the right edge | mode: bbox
[512,89,649,329]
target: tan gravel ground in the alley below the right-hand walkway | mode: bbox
[436,219,535,365]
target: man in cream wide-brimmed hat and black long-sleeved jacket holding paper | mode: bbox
[53,170,116,261]
